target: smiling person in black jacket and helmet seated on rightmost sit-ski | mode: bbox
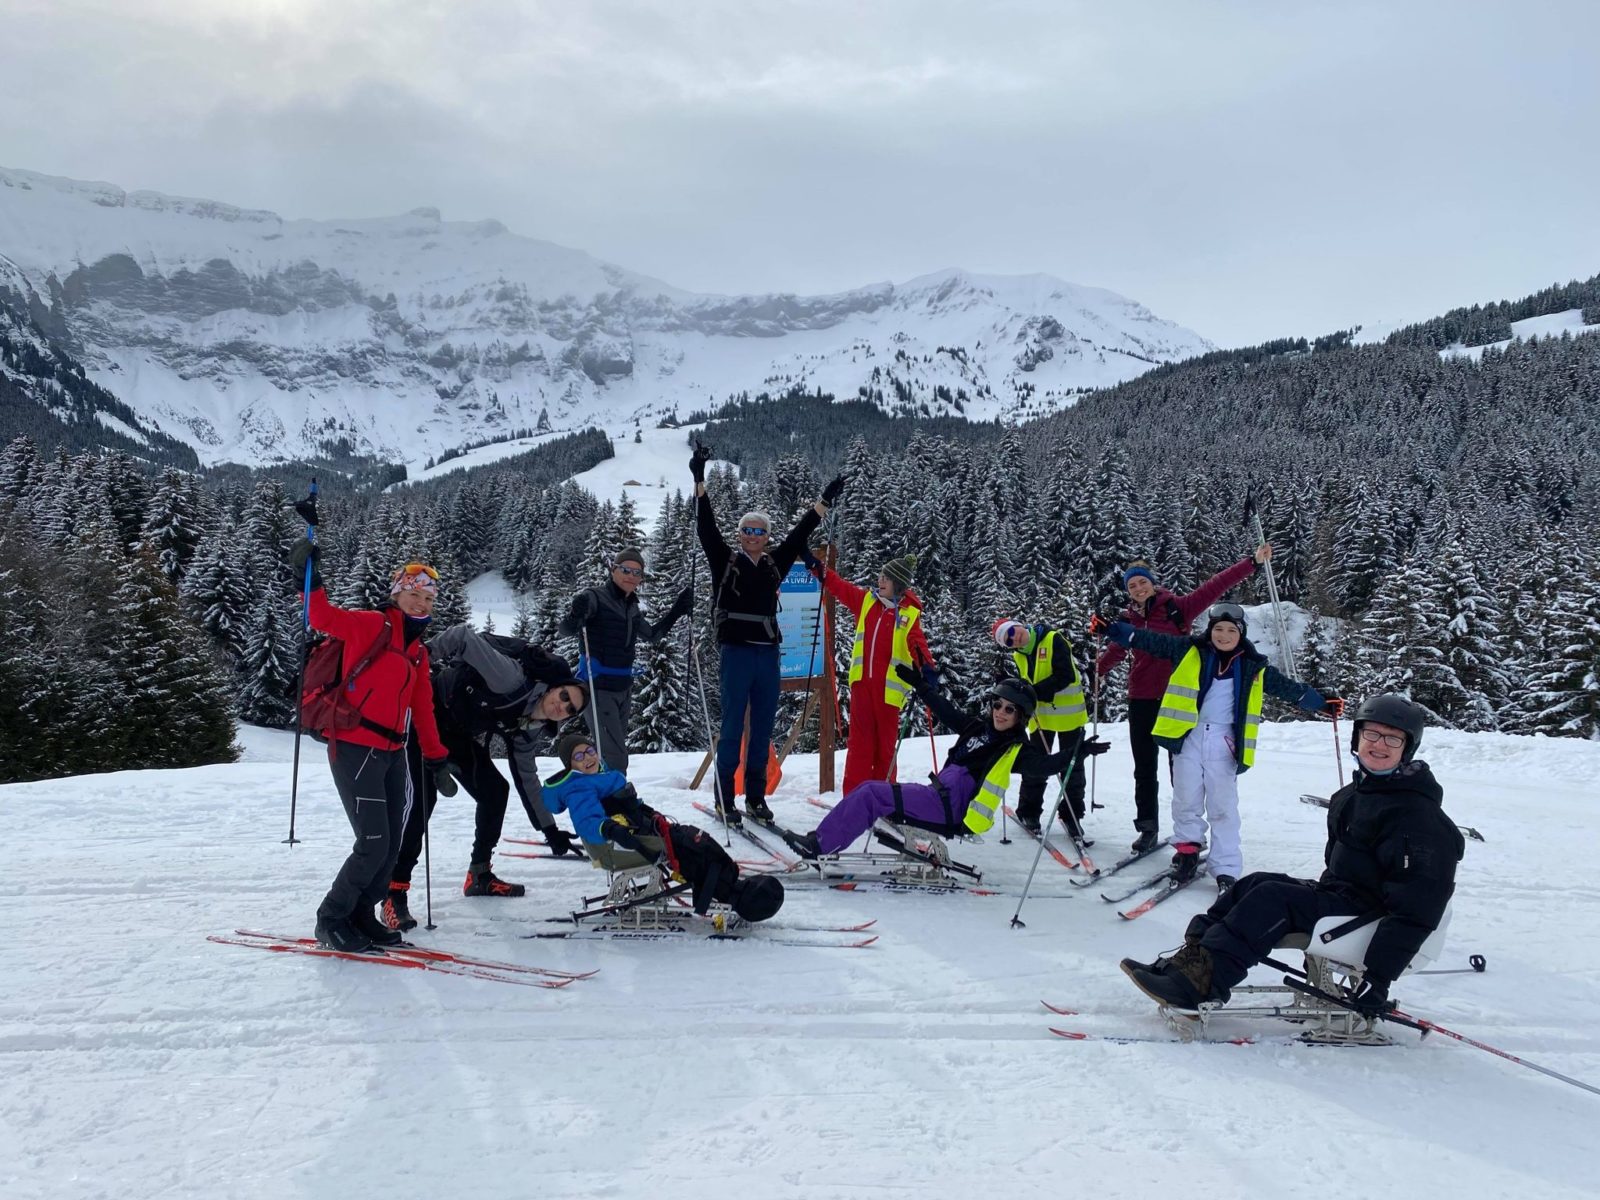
[1122,693,1467,1016]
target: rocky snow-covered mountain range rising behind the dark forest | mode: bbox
[0,168,1211,462]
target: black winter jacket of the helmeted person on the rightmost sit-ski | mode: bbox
[1318,760,1467,982]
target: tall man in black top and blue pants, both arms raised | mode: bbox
[690,442,845,826]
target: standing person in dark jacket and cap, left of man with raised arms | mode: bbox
[558,549,694,771]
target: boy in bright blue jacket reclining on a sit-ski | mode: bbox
[544,733,784,922]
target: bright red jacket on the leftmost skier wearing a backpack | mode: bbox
[310,587,450,758]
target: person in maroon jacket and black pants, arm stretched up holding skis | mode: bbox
[1094,542,1272,853]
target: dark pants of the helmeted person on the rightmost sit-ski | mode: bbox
[1184,870,1363,987]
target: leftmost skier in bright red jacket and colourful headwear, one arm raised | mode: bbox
[293,538,454,952]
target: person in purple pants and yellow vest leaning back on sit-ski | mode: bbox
[786,662,1110,859]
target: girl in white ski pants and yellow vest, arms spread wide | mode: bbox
[1090,603,1344,893]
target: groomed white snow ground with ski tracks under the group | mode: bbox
[0,725,1600,1200]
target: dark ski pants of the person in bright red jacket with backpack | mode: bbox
[317,742,411,920]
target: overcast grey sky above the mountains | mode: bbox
[0,0,1600,344]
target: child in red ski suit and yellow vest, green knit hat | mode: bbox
[805,552,939,795]
